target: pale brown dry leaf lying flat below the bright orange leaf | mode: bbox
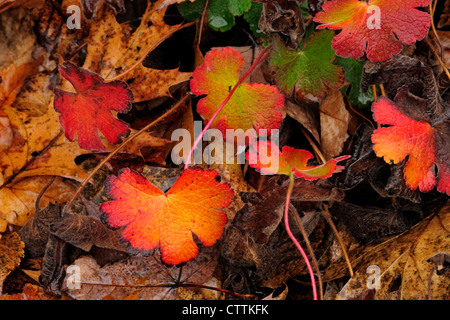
[62,245,219,300]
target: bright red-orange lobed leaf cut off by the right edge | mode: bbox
[372,87,450,195]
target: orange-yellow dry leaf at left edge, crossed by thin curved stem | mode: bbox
[0,176,76,232]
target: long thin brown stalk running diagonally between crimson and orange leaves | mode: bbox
[63,94,191,213]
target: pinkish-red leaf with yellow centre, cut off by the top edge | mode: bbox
[314,0,431,61]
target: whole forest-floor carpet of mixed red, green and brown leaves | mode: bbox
[0,0,450,300]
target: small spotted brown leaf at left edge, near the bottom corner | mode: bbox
[0,232,25,295]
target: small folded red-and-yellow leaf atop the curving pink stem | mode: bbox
[246,141,350,180]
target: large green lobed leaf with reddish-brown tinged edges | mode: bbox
[269,30,345,98]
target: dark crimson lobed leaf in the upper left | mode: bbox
[54,61,133,150]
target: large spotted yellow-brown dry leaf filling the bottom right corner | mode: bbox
[324,204,450,300]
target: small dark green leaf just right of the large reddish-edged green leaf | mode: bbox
[336,57,373,108]
